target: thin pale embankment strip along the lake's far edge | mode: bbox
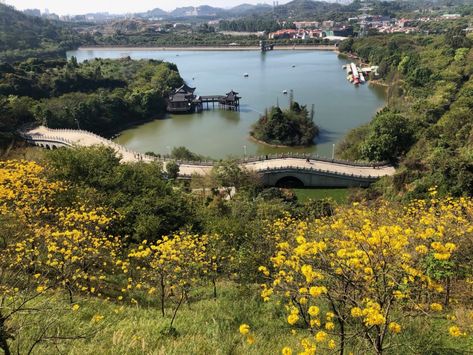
[76,45,337,52]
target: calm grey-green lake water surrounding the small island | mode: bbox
[68,48,385,158]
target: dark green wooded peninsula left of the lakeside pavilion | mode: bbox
[0,58,182,147]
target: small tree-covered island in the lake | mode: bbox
[250,102,319,147]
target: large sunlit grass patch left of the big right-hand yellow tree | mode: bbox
[12,284,297,355]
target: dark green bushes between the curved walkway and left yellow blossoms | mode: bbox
[45,147,198,245]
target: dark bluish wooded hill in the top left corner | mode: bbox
[0,4,81,61]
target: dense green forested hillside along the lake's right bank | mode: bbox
[338,27,473,199]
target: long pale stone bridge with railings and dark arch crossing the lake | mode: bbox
[21,126,395,187]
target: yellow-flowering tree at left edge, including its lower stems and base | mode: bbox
[0,161,122,353]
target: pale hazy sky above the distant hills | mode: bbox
[4,0,289,15]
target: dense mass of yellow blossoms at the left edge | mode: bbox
[0,161,122,299]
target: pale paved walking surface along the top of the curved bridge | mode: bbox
[24,126,395,177]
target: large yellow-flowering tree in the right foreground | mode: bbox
[260,198,473,354]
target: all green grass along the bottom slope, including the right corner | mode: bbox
[11,282,473,355]
